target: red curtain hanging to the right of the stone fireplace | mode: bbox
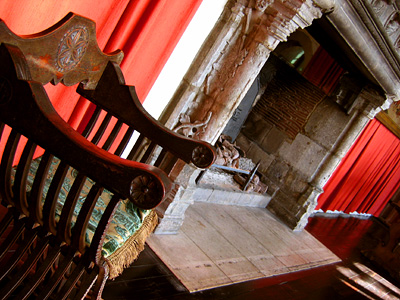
[317,120,400,216]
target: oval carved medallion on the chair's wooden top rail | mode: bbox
[56,27,89,73]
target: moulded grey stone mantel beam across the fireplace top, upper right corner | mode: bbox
[326,0,400,101]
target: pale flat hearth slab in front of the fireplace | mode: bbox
[148,202,340,292]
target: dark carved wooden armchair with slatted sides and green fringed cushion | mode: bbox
[0,14,215,299]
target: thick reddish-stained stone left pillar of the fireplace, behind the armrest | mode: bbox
[155,0,334,233]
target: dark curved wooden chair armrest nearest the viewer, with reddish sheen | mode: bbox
[0,44,171,209]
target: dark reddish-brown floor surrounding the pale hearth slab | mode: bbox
[103,210,400,300]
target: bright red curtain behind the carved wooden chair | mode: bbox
[0,0,202,158]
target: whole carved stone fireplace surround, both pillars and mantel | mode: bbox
[155,0,400,233]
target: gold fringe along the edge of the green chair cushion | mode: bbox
[105,210,158,279]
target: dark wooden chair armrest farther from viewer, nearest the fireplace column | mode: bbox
[77,62,216,168]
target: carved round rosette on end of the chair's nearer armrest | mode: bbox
[130,175,163,209]
